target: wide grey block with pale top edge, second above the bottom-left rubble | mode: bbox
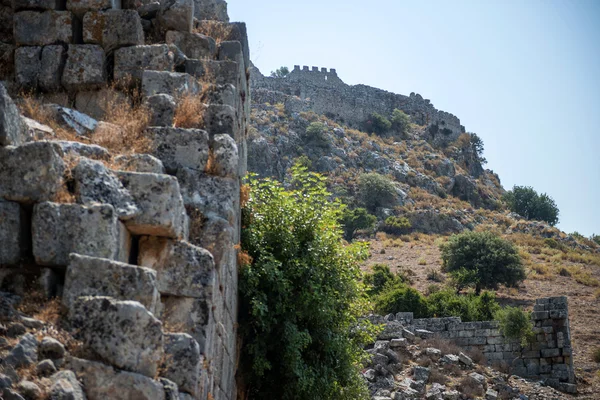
[63,253,160,314]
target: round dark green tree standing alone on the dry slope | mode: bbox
[440,231,525,294]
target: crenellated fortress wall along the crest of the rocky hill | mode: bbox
[251,65,465,143]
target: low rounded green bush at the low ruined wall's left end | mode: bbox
[374,284,429,318]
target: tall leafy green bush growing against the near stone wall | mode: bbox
[239,165,373,400]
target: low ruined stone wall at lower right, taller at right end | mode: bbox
[379,296,577,393]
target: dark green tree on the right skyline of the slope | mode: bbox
[504,186,559,226]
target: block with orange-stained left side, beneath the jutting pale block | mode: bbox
[138,236,215,298]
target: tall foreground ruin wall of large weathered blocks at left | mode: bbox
[0,0,250,400]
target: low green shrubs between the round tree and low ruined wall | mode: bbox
[427,288,500,322]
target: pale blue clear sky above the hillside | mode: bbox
[228,0,600,235]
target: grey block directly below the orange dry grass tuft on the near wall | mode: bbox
[146,127,209,173]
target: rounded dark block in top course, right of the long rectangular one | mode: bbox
[83,10,144,52]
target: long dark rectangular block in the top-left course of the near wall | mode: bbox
[14,11,73,46]
